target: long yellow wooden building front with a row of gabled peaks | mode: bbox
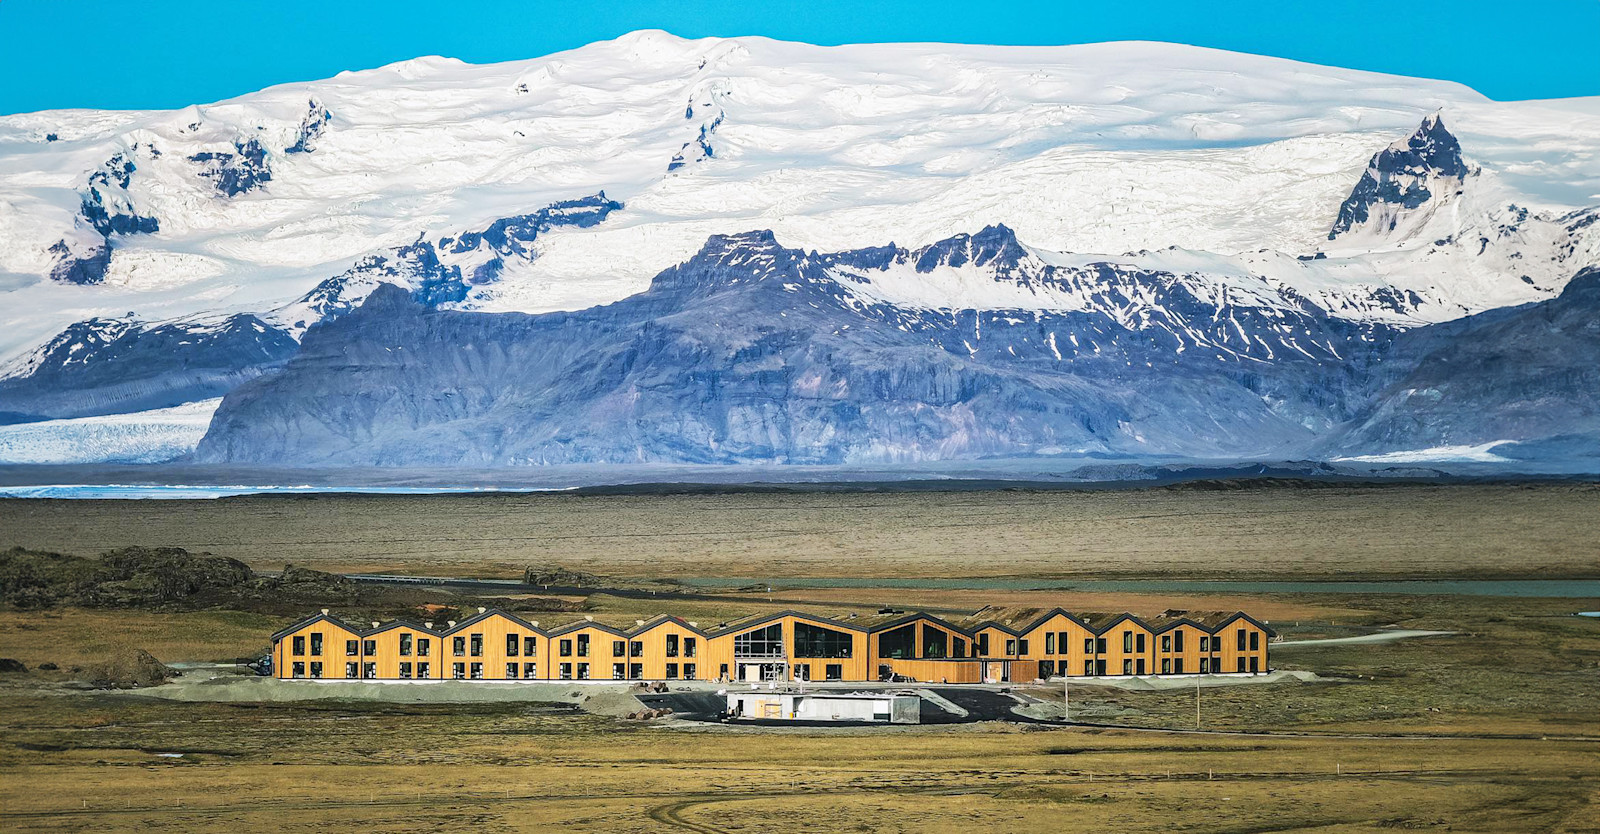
[272,608,1275,684]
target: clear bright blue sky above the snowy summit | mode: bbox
[0,0,1600,114]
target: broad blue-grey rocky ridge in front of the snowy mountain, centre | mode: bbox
[198,229,1387,466]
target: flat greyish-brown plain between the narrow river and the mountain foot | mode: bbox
[0,485,1600,579]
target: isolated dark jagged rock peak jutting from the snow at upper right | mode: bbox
[1328,114,1470,240]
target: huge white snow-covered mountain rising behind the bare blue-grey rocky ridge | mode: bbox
[0,32,1600,461]
